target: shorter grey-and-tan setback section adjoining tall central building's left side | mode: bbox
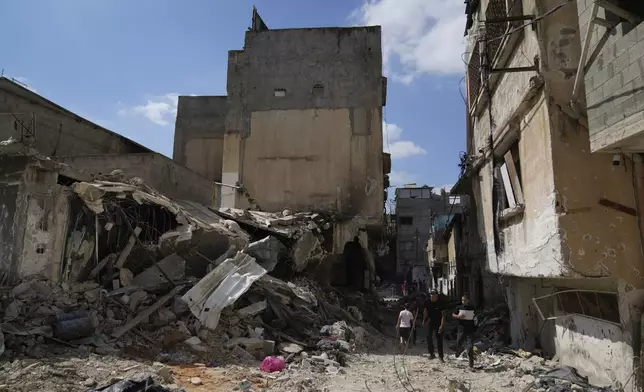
[172,96,227,182]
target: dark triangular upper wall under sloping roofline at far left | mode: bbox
[0,78,150,156]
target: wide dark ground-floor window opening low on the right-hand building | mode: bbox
[533,289,621,324]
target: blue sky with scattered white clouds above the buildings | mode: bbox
[0,0,465,193]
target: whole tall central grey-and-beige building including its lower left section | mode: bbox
[174,10,390,288]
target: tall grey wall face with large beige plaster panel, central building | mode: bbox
[222,27,386,221]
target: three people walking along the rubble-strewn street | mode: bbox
[396,290,475,368]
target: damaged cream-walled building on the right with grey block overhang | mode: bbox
[454,0,644,390]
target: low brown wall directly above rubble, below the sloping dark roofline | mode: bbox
[56,153,215,206]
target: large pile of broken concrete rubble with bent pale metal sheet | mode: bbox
[0,173,382,390]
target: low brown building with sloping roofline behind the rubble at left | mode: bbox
[0,77,216,206]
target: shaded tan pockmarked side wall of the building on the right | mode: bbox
[542,0,644,288]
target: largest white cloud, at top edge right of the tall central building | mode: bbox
[352,0,465,84]
